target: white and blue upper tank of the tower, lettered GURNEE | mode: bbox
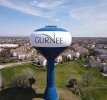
[30,26,72,47]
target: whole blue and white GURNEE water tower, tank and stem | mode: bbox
[31,26,72,100]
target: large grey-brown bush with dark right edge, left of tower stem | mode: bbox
[10,69,36,88]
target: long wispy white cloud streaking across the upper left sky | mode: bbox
[0,0,65,21]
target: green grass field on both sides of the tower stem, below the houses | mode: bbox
[0,61,107,100]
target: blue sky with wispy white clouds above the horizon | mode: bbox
[0,0,107,37]
